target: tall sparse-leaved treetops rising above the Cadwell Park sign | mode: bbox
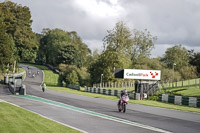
[103,22,157,67]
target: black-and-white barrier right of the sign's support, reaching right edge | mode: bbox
[158,94,200,107]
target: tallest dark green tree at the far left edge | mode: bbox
[0,1,38,61]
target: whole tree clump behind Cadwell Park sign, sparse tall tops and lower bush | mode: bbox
[89,22,156,83]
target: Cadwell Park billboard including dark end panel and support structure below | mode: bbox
[115,69,161,100]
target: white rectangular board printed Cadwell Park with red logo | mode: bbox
[124,69,161,80]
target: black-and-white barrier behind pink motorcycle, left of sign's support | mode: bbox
[85,86,140,100]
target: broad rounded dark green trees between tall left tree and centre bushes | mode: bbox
[38,29,90,67]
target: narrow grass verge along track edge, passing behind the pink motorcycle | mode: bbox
[47,87,200,113]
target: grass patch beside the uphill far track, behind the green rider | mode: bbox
[20,63,59,86]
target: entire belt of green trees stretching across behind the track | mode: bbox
[0,1,200,86]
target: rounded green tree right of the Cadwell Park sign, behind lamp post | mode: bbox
[162,45,189,71]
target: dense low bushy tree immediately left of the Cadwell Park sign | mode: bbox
[89,50,131,83]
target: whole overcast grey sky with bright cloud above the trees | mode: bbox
[0,0,200,57]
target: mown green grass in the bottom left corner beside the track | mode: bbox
[0,102,79,133]
